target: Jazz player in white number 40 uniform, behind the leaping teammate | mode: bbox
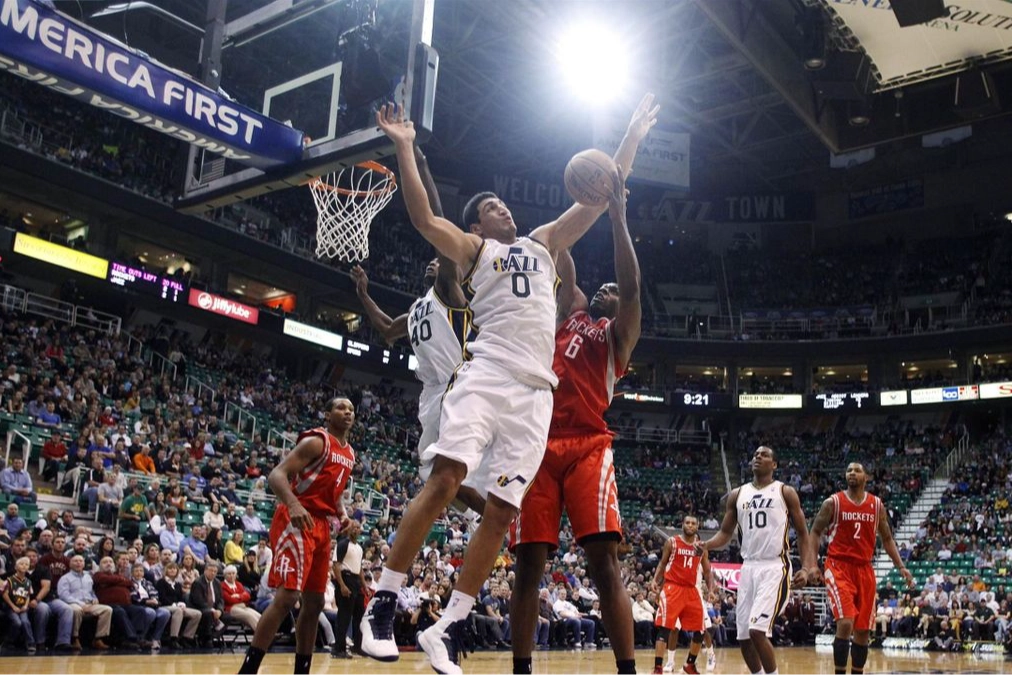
[351,146,485,515]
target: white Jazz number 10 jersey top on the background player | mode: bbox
[737,481,788,562]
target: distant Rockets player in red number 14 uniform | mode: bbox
[654,515,713,675]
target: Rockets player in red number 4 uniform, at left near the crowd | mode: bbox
[239,398,355,675]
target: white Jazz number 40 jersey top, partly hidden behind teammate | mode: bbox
[408,287,468,386]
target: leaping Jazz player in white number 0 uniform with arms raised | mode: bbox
[362,101,636,675]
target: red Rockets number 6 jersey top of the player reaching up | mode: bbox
[549,311,623,438]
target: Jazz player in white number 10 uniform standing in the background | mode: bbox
[700,445,819,675]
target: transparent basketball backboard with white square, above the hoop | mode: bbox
[176,0,437,213]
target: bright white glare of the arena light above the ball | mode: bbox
[558,23,628,103]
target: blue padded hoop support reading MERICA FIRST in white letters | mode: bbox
[0,0,303,167]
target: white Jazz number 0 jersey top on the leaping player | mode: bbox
[463,237,559,389]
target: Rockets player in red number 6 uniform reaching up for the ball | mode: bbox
[510,94,658,675]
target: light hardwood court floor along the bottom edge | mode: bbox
[0,647,1012,675]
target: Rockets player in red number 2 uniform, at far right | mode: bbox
[809,461,914,675]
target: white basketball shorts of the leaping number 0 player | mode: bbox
[420,359,553,508]
